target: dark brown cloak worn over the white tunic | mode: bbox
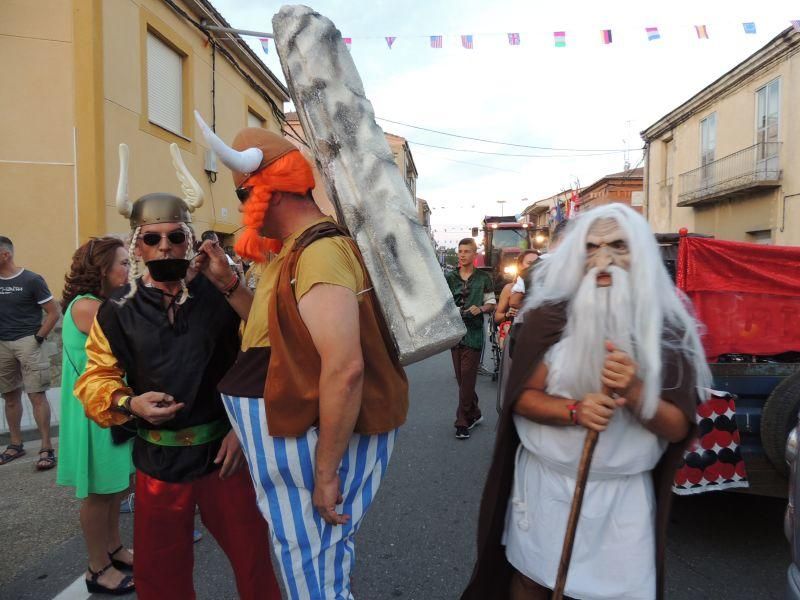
[461,302,698,600]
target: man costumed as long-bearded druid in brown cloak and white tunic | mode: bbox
[462,204,710,600]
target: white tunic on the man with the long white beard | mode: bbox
[503,340,666,600]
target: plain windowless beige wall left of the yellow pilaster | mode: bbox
[0,0,76,293]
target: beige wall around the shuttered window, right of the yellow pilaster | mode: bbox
[103,0,282,241]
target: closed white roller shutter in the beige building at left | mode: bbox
[147,33,183,135]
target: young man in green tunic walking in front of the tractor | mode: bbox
[447,238,497,440]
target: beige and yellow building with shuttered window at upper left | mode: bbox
[0,0,288,296]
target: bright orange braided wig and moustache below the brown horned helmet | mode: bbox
[234,150,314,262]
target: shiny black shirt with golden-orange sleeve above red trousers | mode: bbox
[75,275,239,483]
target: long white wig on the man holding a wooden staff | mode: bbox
[524,204,711,419]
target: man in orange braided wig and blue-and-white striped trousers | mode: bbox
[198,119,408,600]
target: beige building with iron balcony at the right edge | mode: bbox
[642,28,800,245]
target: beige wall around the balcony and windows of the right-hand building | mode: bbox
[645,47,800,245]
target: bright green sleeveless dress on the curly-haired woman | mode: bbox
[56,294,135,498]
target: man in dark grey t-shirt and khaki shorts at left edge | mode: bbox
[0,236,58,471]
